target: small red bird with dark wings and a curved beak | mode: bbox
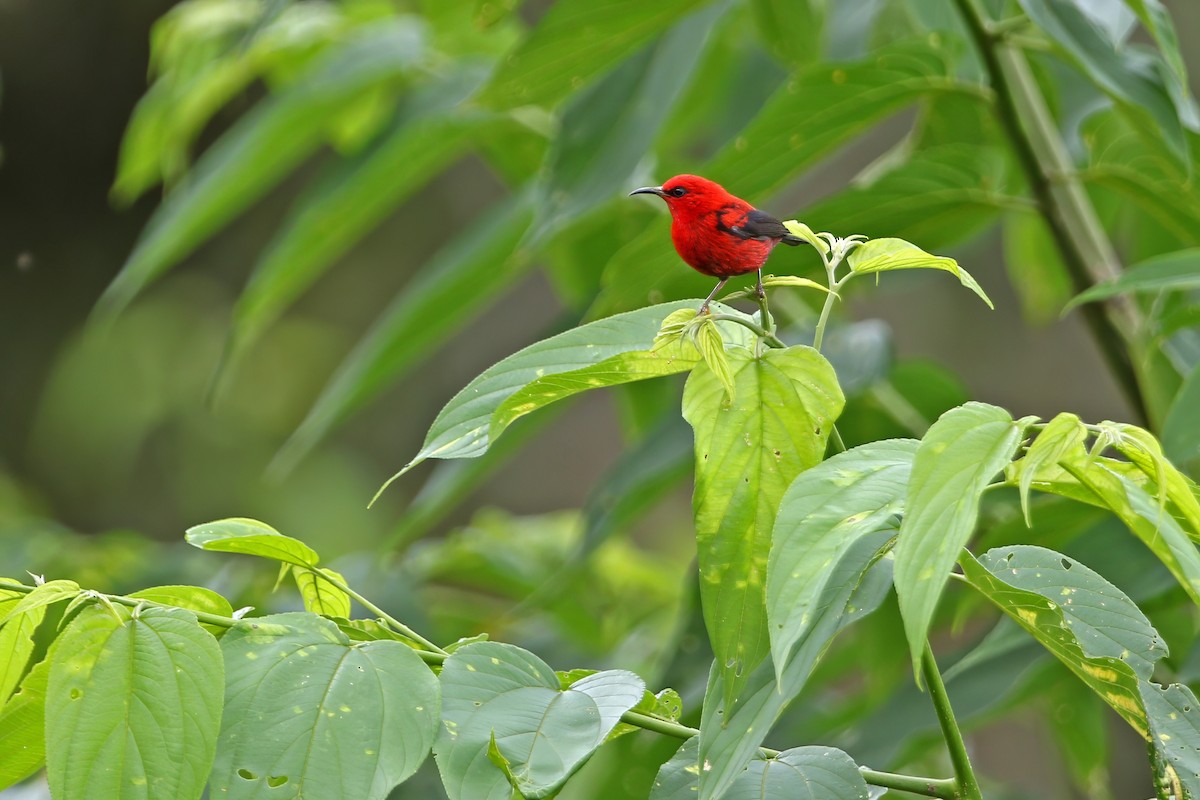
[629,175,804,314]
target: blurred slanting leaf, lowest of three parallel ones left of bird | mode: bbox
[275,196,533,469]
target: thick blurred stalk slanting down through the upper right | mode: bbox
[954,0,1148,421]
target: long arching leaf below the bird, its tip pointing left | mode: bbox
[392,300,746,480]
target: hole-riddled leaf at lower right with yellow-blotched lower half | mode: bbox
[959,546,1165,736]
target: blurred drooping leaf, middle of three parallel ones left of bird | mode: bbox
[230,72,494,362]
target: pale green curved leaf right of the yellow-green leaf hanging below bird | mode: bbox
[767,439,919,669]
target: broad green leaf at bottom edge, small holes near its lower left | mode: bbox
[212,613,439,800]
